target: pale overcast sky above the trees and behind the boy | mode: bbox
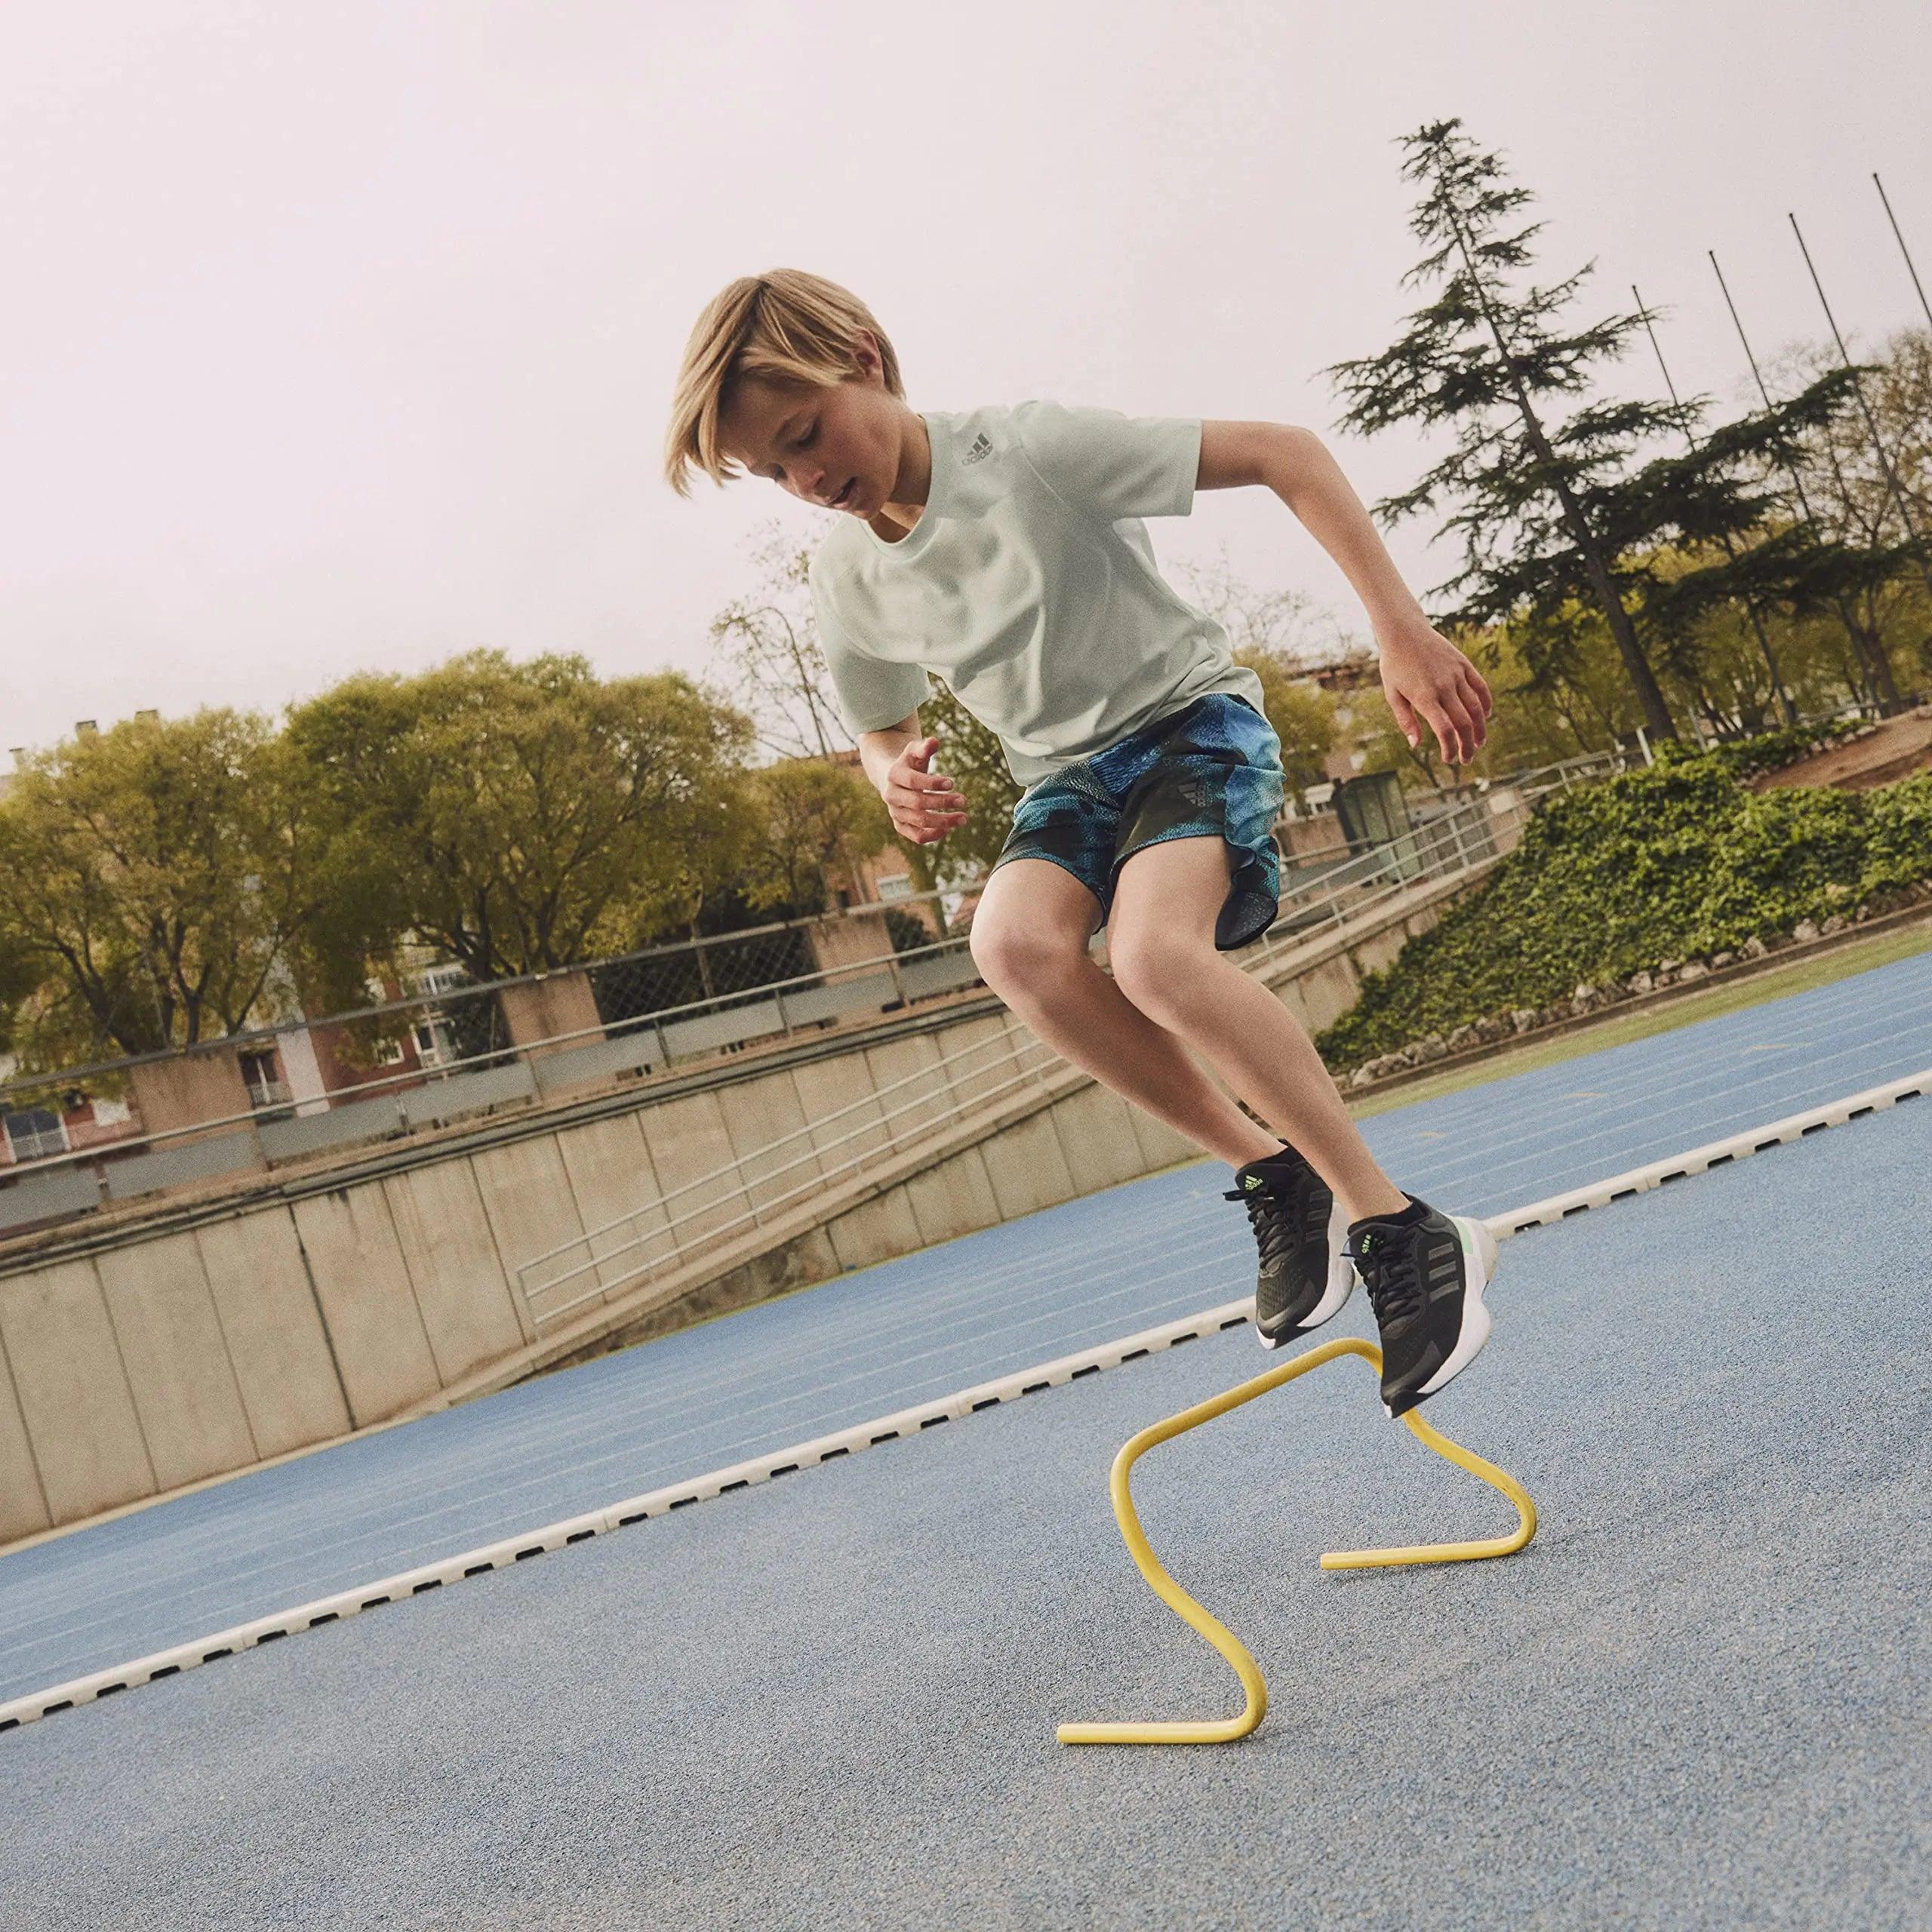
[0,0,1932,769]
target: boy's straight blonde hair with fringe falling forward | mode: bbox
[665,269,906,497]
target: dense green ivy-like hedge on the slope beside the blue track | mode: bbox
[1315,749,1932,1069]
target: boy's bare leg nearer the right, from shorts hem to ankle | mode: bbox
[1107,838,1408,1221]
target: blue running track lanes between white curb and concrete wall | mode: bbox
[0,952,1932,1700]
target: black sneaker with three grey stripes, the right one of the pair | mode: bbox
[1349,1194,1495,1416]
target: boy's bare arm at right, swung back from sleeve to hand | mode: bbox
[1194,421,1491,765]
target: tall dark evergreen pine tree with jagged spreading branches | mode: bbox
[1324,120,1870,736]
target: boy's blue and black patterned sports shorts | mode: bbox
[993,691,1283,952]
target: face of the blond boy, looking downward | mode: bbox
[718,334,918,520]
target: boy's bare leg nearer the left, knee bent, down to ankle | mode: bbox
[972,858,1282,1184]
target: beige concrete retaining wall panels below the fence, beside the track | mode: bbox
[0,881,1447,1542]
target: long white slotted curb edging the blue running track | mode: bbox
[0,1069,1932,1731]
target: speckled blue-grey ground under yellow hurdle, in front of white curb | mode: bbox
[0,1074,1932,1932]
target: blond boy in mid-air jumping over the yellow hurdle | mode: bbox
[665,269,1495,1416]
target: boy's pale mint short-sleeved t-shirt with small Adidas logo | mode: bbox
[811,401,1263,786]
